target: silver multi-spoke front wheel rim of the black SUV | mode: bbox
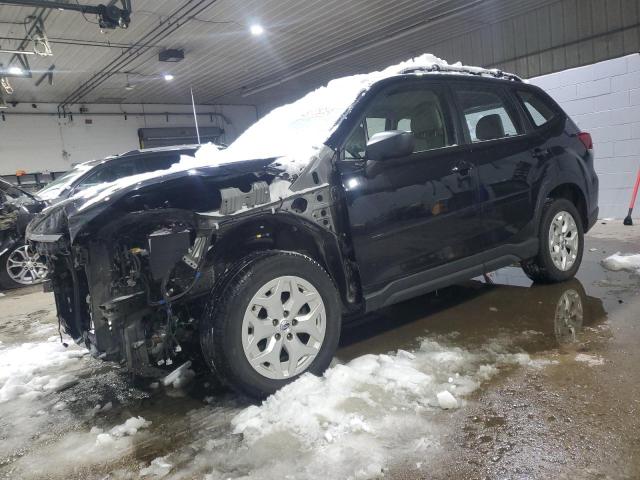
[242,276,327,380]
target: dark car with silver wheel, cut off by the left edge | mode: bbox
[0,180,47,290]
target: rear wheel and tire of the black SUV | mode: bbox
[521,198,584,283]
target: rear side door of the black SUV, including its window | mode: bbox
[452,81,539,249]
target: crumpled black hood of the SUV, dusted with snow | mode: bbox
[27,158,277,243]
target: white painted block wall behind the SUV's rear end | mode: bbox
[530,54,640,218]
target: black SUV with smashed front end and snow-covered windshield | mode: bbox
[28,57,598,397]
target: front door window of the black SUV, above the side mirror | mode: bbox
[344,82,453,160]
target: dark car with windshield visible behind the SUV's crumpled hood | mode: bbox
[37,145,198,203]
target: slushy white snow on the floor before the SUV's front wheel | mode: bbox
[0,318,537,480]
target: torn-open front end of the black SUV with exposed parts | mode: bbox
[27,152,356,376]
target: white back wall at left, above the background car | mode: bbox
[0,104,257,175]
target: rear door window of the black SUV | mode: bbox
[456,88,523,142]
